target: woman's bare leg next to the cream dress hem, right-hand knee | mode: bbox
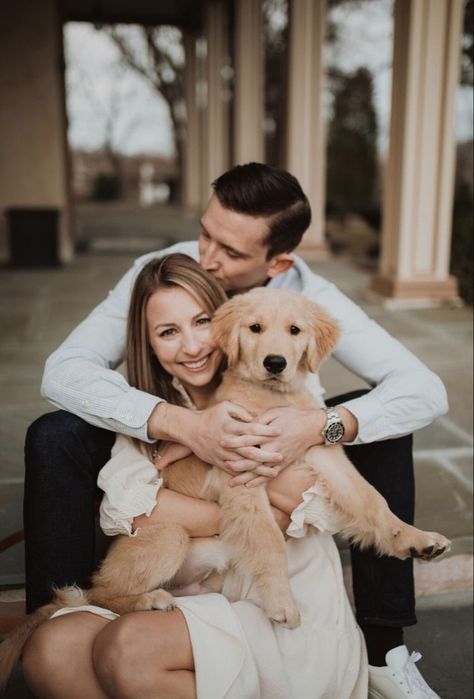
[93,609,196,699]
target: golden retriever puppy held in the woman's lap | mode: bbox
[0,288,449,683]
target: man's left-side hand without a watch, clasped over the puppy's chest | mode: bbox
[148,401,282,475]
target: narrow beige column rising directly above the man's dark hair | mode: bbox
[233,0,265,164]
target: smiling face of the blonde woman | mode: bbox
[146,287,222,388]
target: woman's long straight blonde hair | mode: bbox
[126,253,227,456]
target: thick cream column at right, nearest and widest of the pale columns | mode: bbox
[371,0,463,303]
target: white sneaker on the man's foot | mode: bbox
[369,646,440,699]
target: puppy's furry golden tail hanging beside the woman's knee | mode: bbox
[0,585,88,694]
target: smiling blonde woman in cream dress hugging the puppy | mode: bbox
[23,255,367,699]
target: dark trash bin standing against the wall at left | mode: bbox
[6,207,60,267]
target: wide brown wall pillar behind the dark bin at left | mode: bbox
[0,0,73,262]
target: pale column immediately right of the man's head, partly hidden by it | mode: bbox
[287,0,326,256]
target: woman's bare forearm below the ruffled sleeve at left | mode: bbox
[133,488,220,537]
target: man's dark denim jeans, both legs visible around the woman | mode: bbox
[24,393,416,626]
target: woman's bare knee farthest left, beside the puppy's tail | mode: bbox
[22,612,110,699]
